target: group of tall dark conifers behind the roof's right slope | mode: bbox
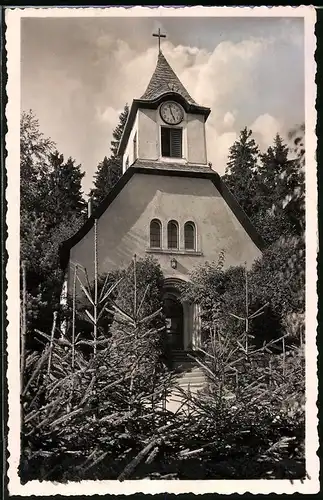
[223,126,305,245]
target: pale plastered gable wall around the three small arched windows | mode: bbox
[69,173,261,292]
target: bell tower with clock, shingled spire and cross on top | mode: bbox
[119,30,211,173]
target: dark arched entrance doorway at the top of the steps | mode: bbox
[164,294,184,351]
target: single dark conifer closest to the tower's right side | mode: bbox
[223,127,259,217]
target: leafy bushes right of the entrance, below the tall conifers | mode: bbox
[183,237,305,346]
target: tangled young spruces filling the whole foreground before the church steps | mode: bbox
[20,254,305,482]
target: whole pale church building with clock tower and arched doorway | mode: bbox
[61,36,263,364]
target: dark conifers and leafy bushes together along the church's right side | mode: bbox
[184,126,305,350]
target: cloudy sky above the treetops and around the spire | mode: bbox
[21,13,304,193]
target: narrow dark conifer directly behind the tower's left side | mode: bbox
[89,104,129,208]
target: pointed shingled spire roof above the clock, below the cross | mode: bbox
[140,51,197,106]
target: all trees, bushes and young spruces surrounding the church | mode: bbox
[20,110,305,482]
